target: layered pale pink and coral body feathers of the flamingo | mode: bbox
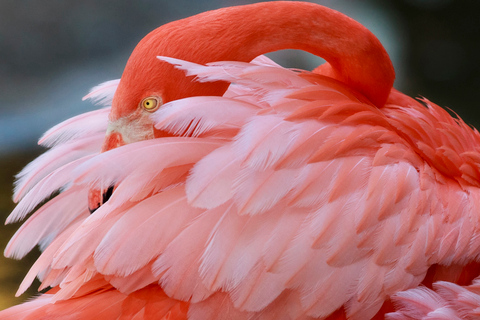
[3,57,480,319]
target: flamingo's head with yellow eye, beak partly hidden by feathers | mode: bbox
[88,25,232,213]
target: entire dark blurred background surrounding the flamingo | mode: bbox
[0,0,480,309]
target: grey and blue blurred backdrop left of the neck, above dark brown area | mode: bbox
[0,0,231,155]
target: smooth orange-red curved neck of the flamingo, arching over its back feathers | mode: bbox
[114,1,395,117]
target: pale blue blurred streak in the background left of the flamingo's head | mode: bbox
[0,57,124,154]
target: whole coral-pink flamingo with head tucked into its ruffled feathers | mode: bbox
[0,1,480,319]
